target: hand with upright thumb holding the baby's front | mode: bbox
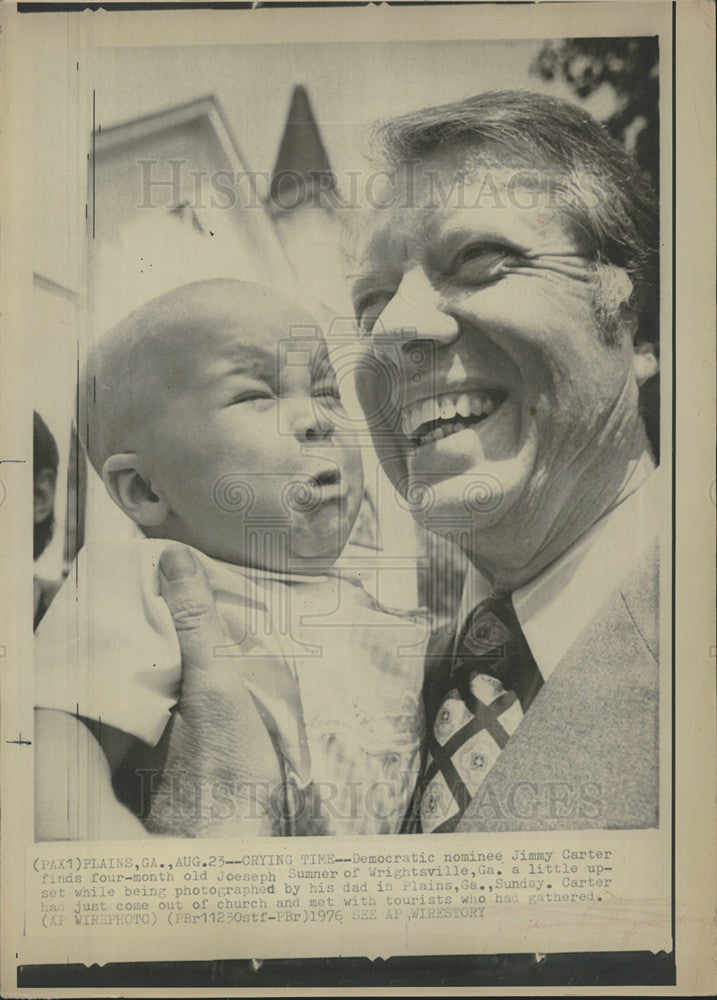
[146,545,282,837]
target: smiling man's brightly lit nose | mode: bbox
[374,265,460,350]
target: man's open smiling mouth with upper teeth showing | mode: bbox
[401,389,508,448]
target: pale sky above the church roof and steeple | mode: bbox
[89,40,608,189]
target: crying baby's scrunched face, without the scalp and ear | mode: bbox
[139,295,363,572]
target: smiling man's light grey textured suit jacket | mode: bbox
[425,544,659,832]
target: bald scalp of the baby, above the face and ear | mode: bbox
[80,278,310,475]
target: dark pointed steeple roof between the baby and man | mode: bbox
[269,85,336,211]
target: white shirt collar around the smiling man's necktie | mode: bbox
[456,470,665,681]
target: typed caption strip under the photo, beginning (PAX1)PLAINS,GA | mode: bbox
[26,833,670,962]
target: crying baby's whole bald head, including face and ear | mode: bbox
[82,279,363,570]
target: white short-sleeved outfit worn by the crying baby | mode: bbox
[36,538,428,835]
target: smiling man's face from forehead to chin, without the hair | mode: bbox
[354,146,640,576]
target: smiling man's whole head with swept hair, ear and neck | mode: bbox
[354,92,657,586]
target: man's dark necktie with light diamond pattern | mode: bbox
[419,595,543,833]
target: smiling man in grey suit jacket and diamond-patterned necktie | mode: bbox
[354,92,660,832]
